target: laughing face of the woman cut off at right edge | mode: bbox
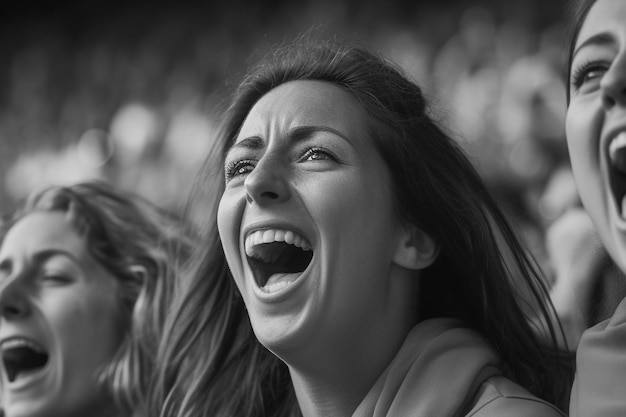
[566,0,626,271]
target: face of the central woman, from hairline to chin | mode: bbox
[218,81,412,353]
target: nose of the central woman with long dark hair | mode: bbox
[244,158,291,206]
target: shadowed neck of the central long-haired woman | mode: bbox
[274,271,419,417]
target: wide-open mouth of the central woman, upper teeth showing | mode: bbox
[245,229,313,292]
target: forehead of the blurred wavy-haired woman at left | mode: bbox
[0,211,84,258]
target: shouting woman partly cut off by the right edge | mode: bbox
[566,0,626,417]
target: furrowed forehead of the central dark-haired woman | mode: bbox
[239,80,367,137]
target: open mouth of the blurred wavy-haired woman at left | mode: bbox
[0,338,49,382]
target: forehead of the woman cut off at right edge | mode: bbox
[577,0,626,44]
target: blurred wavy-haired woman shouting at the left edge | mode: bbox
[0,183,191,417]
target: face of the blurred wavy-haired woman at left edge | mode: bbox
[0,212,122,417]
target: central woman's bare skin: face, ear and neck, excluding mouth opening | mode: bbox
[218,81,436,415]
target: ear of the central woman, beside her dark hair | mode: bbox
[393,225,439,270]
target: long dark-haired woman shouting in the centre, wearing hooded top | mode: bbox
[150,42,571,417]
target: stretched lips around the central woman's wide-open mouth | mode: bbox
[239,220,317,303]
